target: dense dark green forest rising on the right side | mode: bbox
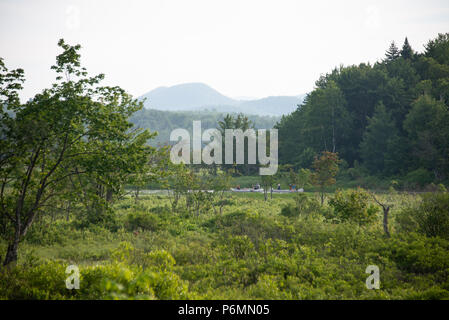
[276,33,449,185]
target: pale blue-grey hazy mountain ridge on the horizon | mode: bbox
[139,82,305,116]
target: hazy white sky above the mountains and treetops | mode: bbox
[0,0,449,98]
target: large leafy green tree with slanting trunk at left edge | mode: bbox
[0,40,151,265]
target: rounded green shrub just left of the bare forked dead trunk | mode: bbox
[329,188,379,225]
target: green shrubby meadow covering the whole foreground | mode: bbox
[0,193,449,299]
